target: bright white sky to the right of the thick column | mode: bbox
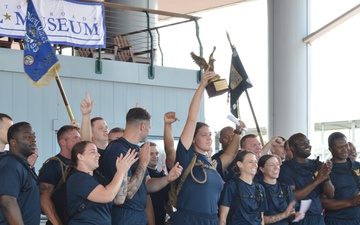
[311,0,360,155]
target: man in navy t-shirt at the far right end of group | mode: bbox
[322,132,360,225]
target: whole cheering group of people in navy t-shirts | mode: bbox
[0,71,360,225]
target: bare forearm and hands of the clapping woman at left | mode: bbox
[88,150,138,203]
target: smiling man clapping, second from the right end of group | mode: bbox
[278,133,334,225]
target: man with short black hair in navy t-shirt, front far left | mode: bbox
[0,122,41,224]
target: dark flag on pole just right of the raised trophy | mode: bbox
[229,46,252,118]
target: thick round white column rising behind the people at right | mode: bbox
[268,0,312,139]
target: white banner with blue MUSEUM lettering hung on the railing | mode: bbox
[0,0,106,48]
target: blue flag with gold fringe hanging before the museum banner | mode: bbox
[23,0,60,87]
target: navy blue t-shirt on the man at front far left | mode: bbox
[0,153,41,225]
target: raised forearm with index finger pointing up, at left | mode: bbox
[80,92,94,141]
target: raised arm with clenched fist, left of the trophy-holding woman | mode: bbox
[164,112,177,169]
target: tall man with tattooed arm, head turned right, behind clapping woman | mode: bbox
[100,107,182,225]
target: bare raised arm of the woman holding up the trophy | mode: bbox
[180,70,216,149]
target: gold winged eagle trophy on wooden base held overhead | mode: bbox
[190,46,229,98]
